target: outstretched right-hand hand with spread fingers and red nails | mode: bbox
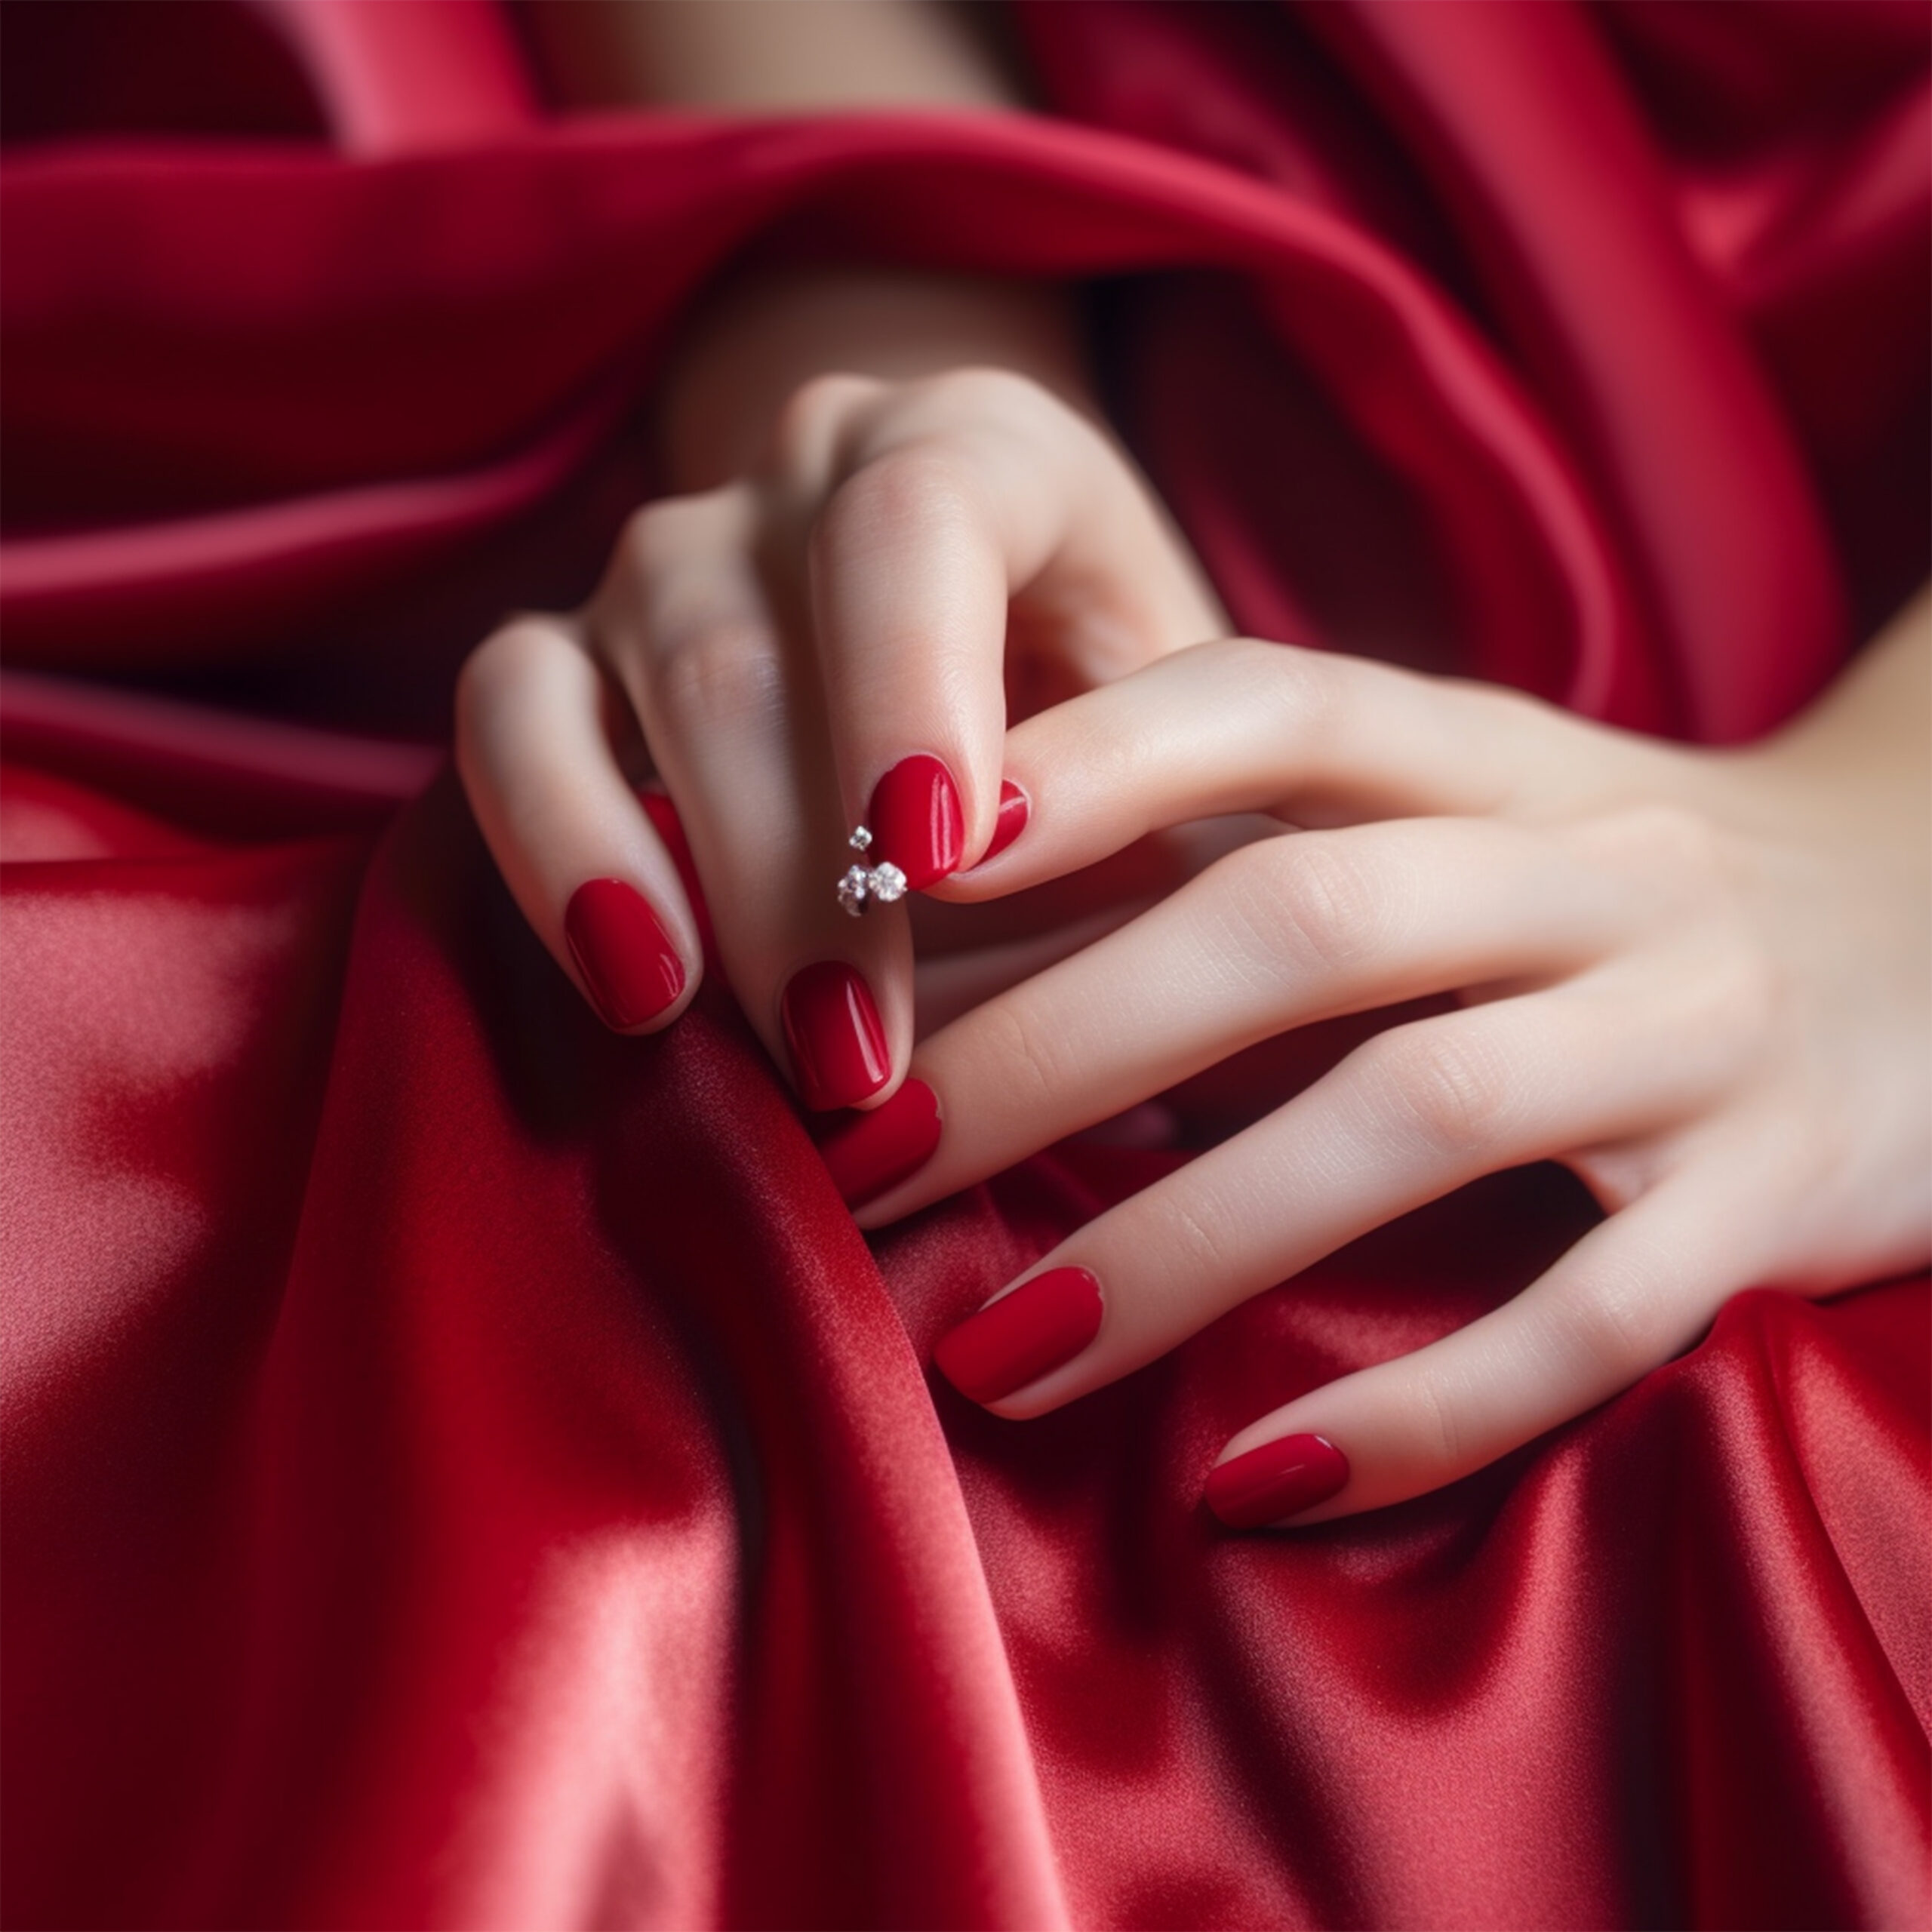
[861,607,1932,1526]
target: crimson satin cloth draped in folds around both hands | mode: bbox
[0,0,1932,1928]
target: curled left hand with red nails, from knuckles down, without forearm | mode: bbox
[456,363,1225,1109]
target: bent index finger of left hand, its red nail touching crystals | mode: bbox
[788,371,1217,891]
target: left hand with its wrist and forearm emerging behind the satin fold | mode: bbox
[467,0,1227,1107]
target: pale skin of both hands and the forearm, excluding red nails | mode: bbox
[458,11,1932,1522]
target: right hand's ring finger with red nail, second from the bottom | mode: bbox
[919,968,1721,1416]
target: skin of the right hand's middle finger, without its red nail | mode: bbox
[860,819,1629,1227]
